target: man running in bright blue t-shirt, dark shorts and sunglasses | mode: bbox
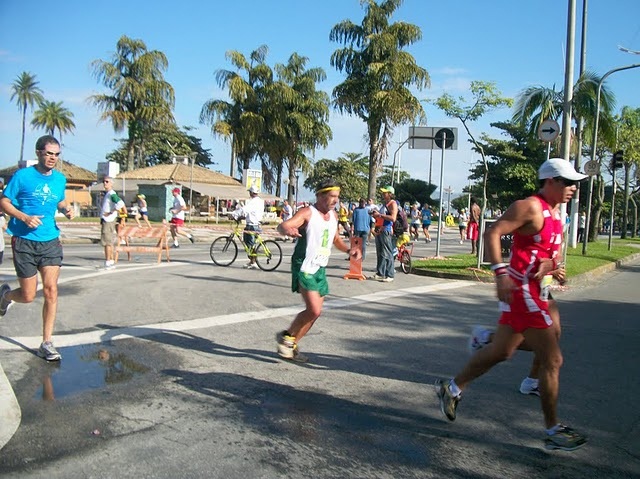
[0,135,73,361]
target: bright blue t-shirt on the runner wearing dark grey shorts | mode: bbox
[4,166,67,241]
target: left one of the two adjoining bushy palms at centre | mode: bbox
[200,45,273,176]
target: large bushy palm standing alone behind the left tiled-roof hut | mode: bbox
[88,35,175,170]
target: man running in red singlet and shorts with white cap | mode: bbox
[436,158,587,451]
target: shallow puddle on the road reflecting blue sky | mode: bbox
[34,345,149,401]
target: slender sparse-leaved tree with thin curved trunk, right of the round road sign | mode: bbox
[435,81,513,267]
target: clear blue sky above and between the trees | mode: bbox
[0,0,640,197]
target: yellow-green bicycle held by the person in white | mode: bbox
[209,220,282,271]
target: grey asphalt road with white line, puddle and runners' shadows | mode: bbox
[0,235,640,478]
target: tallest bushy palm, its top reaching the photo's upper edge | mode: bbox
[329,0,430,198]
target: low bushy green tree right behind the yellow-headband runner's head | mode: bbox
[304,153,369,201]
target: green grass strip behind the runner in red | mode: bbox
[413,238,640,279]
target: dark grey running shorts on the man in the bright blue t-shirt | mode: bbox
[11,236,62,278]
